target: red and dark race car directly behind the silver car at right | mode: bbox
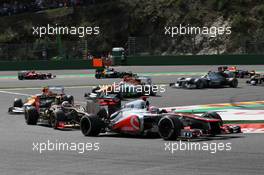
[218,66,256,78]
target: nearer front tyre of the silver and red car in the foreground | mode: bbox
[158,116,183,140]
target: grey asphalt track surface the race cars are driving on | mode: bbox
[0,66,264,175]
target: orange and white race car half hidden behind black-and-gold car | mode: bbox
[8,86,74,114]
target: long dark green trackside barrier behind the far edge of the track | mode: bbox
[0,55,264,70]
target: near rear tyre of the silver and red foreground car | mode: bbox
[80,115,103,136]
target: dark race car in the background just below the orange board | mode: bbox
[95,67,136,79]
